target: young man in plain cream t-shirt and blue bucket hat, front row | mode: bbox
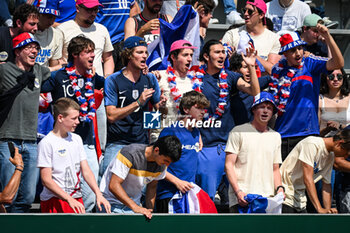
[225,92,284,213]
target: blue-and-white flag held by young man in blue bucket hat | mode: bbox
[238,193,284,214]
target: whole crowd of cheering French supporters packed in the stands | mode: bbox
[0,0,350,219]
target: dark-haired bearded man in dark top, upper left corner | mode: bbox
[0,4,39,63]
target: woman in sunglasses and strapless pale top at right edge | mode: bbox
[318,69,350,213]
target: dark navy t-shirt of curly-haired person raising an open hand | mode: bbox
[231,75,271,125]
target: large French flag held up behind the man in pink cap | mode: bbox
[146,5,200,71]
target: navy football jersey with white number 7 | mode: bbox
[104,71,160,145]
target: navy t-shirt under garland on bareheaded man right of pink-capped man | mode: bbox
[200,70,240,147]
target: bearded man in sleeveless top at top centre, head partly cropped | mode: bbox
[124,0,173,44]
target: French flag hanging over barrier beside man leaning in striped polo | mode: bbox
[168,183,218,214]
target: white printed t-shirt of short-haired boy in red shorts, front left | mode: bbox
[37,132,86,201]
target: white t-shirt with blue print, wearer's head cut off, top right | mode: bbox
[266,0,311,32]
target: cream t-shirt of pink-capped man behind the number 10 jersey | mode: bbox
[57,20,113,76]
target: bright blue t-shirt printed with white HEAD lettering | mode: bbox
[157,125,199,200]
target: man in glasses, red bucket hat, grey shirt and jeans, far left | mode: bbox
[0,32,50,213]
